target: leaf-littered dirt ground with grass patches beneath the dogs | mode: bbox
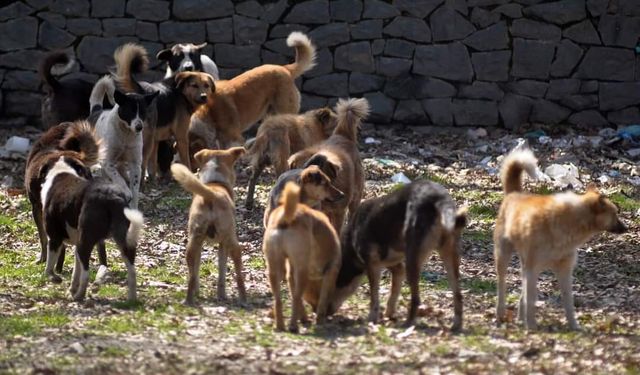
[0,126,640,374]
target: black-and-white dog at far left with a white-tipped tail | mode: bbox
[40,123,143,301]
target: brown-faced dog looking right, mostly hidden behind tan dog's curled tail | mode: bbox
[263,165,344,228]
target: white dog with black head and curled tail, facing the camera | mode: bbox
[89,71,158,208]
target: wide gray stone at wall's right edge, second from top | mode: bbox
[578,47,635,81]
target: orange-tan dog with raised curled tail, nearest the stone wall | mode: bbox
[189,32,316,153]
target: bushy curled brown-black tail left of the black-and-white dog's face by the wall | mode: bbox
[113,43,149,93]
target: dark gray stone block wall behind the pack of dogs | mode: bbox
[0,0,640,128]
